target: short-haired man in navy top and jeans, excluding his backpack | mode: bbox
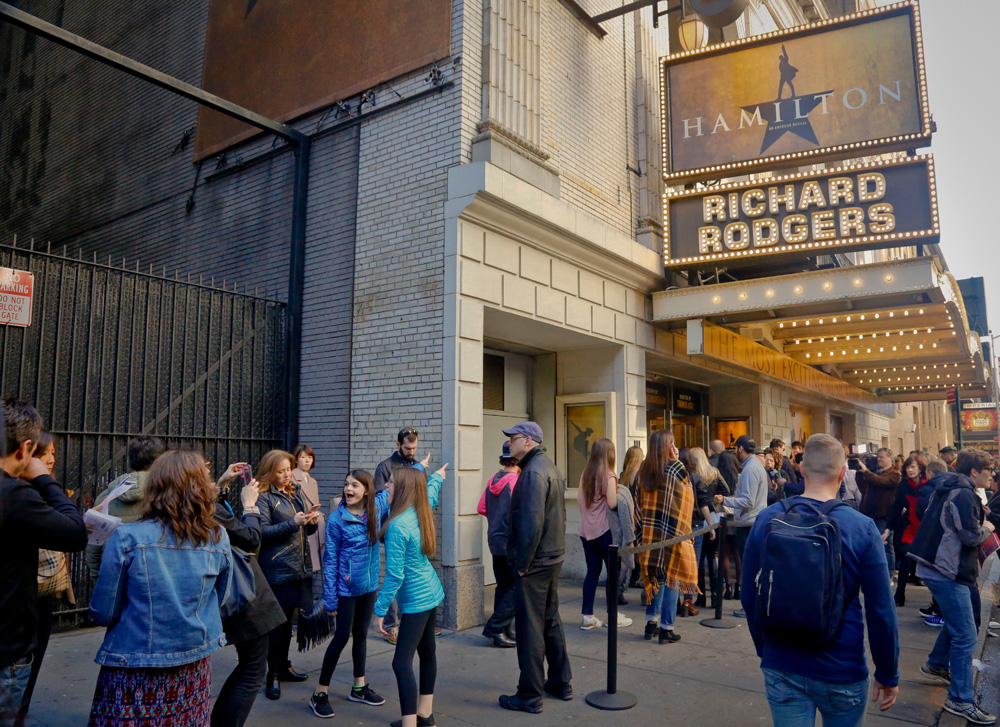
[742,434,899,727]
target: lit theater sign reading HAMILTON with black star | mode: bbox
[661,2,931,184]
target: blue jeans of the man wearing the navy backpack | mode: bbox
[762,669,868,727]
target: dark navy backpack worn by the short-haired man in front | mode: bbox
[754,497,848,646]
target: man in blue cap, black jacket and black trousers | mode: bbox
[500,422,573,714]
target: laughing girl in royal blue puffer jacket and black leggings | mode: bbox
[309,470,391,718]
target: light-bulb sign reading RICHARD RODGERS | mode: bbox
[664,156,940,267]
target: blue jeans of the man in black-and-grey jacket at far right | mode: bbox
[924,578,976,702]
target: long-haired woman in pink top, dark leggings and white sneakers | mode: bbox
[577,437,632,631]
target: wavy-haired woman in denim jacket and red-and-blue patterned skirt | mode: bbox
[90,451,231,727]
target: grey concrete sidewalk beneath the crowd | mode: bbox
[28,580,945,727]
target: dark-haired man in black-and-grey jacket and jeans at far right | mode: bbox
[909,449,996,724]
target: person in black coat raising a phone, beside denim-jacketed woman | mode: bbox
[212,462,286,727]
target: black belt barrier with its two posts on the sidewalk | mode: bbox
[586,516,753,710]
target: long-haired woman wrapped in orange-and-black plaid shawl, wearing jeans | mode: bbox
[638,430,700,644]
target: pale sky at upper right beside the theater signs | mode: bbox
[912,0,1000,348]
